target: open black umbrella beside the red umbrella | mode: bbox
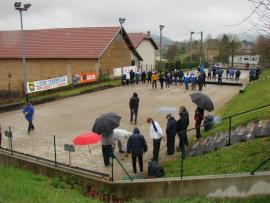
[92,113,121,134]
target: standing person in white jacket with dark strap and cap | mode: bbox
[146,118,163,162]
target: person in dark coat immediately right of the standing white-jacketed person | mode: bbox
[166,114,176,156]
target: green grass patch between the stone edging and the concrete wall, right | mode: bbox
[162,137,270,177]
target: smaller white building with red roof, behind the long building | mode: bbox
[128,32,158,71]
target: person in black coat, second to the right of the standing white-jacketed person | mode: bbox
[176,106,189,150]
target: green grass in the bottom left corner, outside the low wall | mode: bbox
[0,166,96,203]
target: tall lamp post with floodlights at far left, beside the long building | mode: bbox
[14,2,31,102]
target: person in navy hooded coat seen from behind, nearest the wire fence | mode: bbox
[127,127,147,175]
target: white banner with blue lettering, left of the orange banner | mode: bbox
[27,76,68,93]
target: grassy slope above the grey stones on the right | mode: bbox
[203,69,270,137]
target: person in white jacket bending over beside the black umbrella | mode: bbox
[113,128,132,153]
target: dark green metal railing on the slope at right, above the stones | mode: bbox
[180,104,270,179]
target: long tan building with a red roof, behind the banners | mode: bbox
[0,27,142,90]
